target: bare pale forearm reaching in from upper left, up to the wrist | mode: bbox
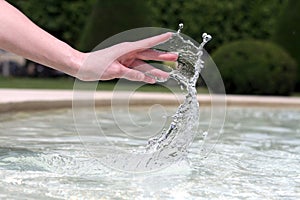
[0,0,84,76]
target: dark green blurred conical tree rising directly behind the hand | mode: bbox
[79,0,152,51]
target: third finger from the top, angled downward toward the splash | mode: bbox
[132,60,169,80]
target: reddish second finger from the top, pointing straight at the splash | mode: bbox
[136,49,178,61]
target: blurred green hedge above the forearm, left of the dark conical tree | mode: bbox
[9,0,95,46]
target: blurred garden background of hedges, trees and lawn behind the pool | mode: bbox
[0,0,300,96]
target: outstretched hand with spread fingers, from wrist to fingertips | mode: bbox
[75,33,178,83]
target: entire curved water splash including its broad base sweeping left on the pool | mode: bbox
[102,23,212,172]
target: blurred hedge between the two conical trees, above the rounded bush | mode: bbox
[149,0,286,50]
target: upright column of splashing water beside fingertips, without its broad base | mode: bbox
[147,24,212,151]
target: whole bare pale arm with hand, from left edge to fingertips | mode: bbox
[0,0,178,83]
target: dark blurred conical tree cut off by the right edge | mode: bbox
[273,0,300,91]
